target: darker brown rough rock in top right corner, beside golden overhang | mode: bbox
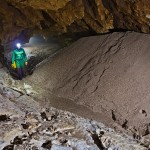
[103,0,150,33]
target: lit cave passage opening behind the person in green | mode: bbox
[5,35,61,79]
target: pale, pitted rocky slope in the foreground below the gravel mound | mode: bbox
[0,63,147,150]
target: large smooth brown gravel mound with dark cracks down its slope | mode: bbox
[27,32,150,141]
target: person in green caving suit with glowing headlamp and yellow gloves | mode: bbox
[12,43,28,80]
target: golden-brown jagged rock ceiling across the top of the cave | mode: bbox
[0,0,150,41]
